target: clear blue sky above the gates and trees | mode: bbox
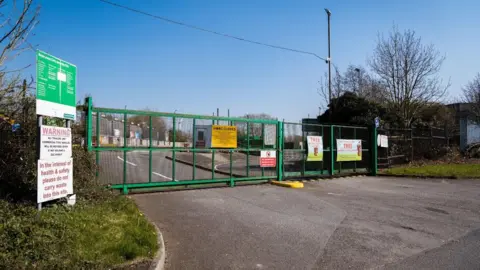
[11,0,480,121]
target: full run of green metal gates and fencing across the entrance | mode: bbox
[85,98,376,194]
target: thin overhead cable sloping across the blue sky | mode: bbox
[99,0,328,62]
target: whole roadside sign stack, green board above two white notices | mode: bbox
[36,50,77,210]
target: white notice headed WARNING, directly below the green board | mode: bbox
[40,125,72,160]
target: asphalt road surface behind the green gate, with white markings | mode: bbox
[99,151,226,184]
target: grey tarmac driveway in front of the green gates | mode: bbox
[134,177,480,269]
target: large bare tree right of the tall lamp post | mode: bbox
[369,27,450,127]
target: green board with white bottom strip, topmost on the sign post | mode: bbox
[37,50,77,120]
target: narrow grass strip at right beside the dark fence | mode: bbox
[385,164,480,178]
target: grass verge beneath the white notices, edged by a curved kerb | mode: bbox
[0,196,158,269]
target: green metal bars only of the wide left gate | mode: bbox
[86,97,283,194]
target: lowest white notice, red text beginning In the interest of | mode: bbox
[37,158,73,203]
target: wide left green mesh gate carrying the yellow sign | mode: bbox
[87,100,279,193]
